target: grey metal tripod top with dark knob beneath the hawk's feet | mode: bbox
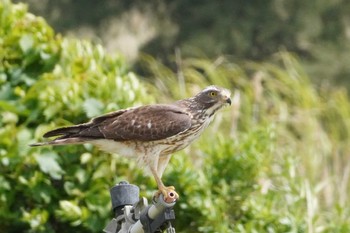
[103,181,176,233]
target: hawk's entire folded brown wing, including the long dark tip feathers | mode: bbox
[44,104,191,141]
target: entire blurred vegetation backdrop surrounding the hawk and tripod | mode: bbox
[0,0,350,233]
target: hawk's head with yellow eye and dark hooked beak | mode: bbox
[194,86,231,115]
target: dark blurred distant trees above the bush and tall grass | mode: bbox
[17,0,350,90]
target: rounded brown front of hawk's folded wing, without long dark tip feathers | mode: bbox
[98,104,191,141]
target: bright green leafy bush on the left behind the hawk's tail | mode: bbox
[0,1,152,232]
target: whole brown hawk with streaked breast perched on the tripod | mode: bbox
[31,86,231,199]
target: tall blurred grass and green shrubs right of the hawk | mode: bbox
[142,52,350,232]
